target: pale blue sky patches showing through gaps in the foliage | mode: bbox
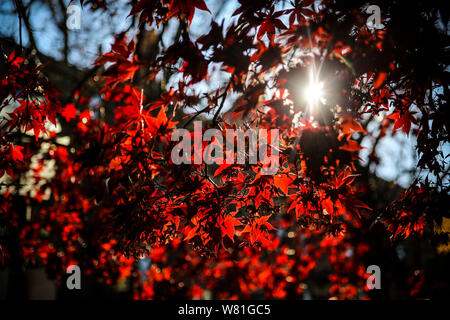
[0,0,436,187]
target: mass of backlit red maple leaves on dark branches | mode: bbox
[0,0,448,299]
